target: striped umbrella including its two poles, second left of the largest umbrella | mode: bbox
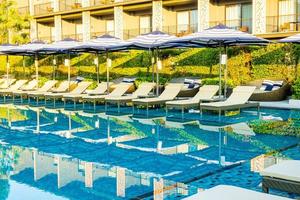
[70,34,132,93]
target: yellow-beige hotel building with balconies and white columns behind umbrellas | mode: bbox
[17,0,300,42]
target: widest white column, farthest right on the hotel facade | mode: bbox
[252,0,267,34]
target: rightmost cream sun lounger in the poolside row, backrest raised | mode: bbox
[200,86,259,116]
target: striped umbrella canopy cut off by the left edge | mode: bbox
[2,40,46,55]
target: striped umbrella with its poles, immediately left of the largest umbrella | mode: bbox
[129,31,177,95]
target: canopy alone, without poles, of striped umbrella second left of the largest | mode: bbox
[70,34,132,52]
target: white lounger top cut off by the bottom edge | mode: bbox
[184,185,291,200]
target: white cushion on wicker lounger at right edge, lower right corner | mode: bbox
[260,160,300,182]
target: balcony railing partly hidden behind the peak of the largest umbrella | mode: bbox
[209,18,252,33]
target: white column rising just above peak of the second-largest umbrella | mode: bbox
[152,0,164,31]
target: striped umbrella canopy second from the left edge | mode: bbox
[36,38,82,54]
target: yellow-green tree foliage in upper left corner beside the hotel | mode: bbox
[0,0,30,44]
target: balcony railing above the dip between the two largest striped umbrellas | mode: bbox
[163,24,198,37]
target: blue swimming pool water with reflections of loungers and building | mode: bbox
[0,104,300,199]
